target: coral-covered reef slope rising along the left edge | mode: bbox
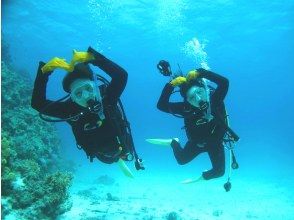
[1,61,73,219]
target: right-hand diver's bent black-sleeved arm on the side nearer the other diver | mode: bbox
[157,83,183,114]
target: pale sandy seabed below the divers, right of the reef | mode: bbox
[59,163,294,220]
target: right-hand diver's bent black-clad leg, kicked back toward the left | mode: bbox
[171,140,204,165]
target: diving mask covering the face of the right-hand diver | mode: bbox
[186,86,209,109]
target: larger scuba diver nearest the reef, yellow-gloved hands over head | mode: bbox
[31,47,144,176]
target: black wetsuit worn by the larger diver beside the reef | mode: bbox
[31,54,128,163]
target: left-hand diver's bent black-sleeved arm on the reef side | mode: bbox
[31,62,68,118]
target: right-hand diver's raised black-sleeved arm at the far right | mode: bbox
[197,68,229,104]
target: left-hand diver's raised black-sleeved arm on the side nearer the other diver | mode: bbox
[88,47,128,103]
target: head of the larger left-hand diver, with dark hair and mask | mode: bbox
[62,63,101,107]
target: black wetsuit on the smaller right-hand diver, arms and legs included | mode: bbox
[157,69,229,179]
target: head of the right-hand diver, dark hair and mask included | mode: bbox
[180,79,209,109]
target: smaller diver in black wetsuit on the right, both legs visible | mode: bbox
[157,69,229,180]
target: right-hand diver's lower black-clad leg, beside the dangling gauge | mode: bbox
[202,141,225,180]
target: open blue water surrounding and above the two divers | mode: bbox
[2,0,294,218]
